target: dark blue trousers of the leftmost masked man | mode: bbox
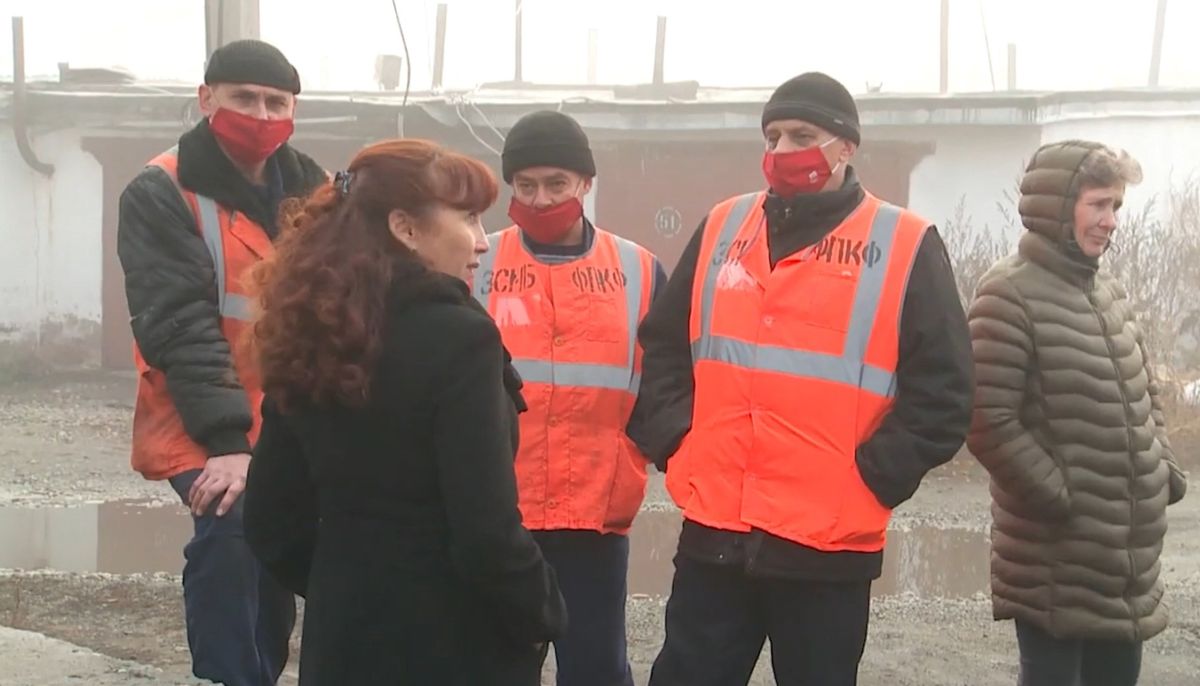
[170,470,296,686]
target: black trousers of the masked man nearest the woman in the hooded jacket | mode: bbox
[650,555,871,686]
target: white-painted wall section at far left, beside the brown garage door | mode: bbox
[0,126,104,362]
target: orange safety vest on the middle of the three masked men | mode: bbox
[473,227,654,534]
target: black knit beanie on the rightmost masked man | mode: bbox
[762,72,863,145]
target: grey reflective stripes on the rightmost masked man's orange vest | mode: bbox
[692,193,900,398]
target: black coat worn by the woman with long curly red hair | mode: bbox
[245,271,566,686]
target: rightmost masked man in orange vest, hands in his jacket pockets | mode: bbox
[630,73,972,686]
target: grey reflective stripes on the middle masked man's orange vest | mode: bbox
[472,231,646,395]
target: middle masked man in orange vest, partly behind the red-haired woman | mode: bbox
[473,112,666,686]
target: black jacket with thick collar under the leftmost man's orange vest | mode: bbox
[116,120,325,456]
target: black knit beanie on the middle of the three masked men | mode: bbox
[500,110,596,183]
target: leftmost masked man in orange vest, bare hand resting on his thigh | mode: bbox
[118,41,326,686]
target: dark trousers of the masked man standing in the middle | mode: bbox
[533,531,634,686]
